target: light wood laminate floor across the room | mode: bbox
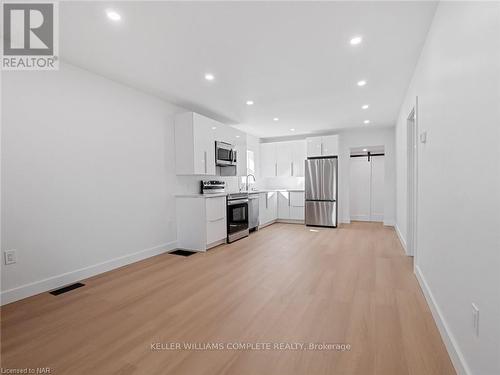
[1,223,455,375]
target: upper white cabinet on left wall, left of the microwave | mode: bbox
[175,112,217,175]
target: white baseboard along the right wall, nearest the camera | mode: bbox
[415,265,472,375]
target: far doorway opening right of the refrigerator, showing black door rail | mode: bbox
[349,146,385,222]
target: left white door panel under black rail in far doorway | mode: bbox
[349,157,370,221]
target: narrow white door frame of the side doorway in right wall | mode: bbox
[406,97,418,264]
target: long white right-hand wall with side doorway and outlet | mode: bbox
[396,2,500,375]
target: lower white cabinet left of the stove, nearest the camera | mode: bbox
[176,196,227,251]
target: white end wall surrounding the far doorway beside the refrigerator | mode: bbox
[339,127,396,225]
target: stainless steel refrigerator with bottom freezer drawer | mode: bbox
[305,157,338,228]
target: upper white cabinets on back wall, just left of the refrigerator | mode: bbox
[260,141,306,177]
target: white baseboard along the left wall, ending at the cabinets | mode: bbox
[0,241,177,306]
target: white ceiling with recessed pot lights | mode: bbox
[59,1,436,137]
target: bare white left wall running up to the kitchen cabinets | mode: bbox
[1,64,182,303]
